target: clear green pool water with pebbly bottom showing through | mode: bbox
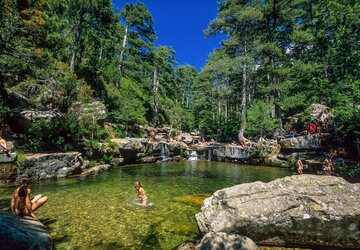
[0,161,291,249]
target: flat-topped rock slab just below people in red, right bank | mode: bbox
[280,134,321,150]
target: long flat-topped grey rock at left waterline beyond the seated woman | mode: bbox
[18,152,88,180]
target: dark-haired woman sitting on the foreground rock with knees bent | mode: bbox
[11,177,48,220]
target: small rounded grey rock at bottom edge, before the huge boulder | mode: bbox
[195,232,259,250]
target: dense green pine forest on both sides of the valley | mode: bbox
[0,0,360,152]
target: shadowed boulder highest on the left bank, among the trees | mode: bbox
[6,109,64,132]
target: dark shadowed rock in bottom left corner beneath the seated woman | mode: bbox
[0,213,52,250]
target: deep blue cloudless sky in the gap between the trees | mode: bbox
[113,0,224,71]
